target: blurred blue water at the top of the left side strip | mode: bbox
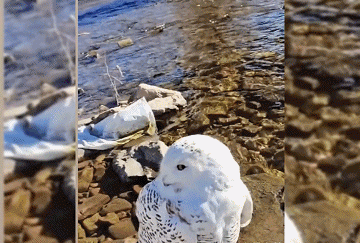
[4,0,75,107]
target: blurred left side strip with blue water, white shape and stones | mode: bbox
[1,0,77,243]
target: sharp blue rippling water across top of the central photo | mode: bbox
[78,0,284,117]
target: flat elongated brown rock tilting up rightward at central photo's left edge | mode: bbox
[78,194,110,220]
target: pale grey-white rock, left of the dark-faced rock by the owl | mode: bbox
[112,154,144,183]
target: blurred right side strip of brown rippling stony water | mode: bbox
[285,0,360,243]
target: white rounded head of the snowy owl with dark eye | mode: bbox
[157,135,240,198]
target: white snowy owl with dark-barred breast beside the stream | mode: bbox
[136,135,253,243]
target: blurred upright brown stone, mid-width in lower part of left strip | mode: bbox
[32,186,52,215]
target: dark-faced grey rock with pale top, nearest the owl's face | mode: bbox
[130,141,168,171]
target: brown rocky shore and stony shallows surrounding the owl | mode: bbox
[78,45,285,242]
